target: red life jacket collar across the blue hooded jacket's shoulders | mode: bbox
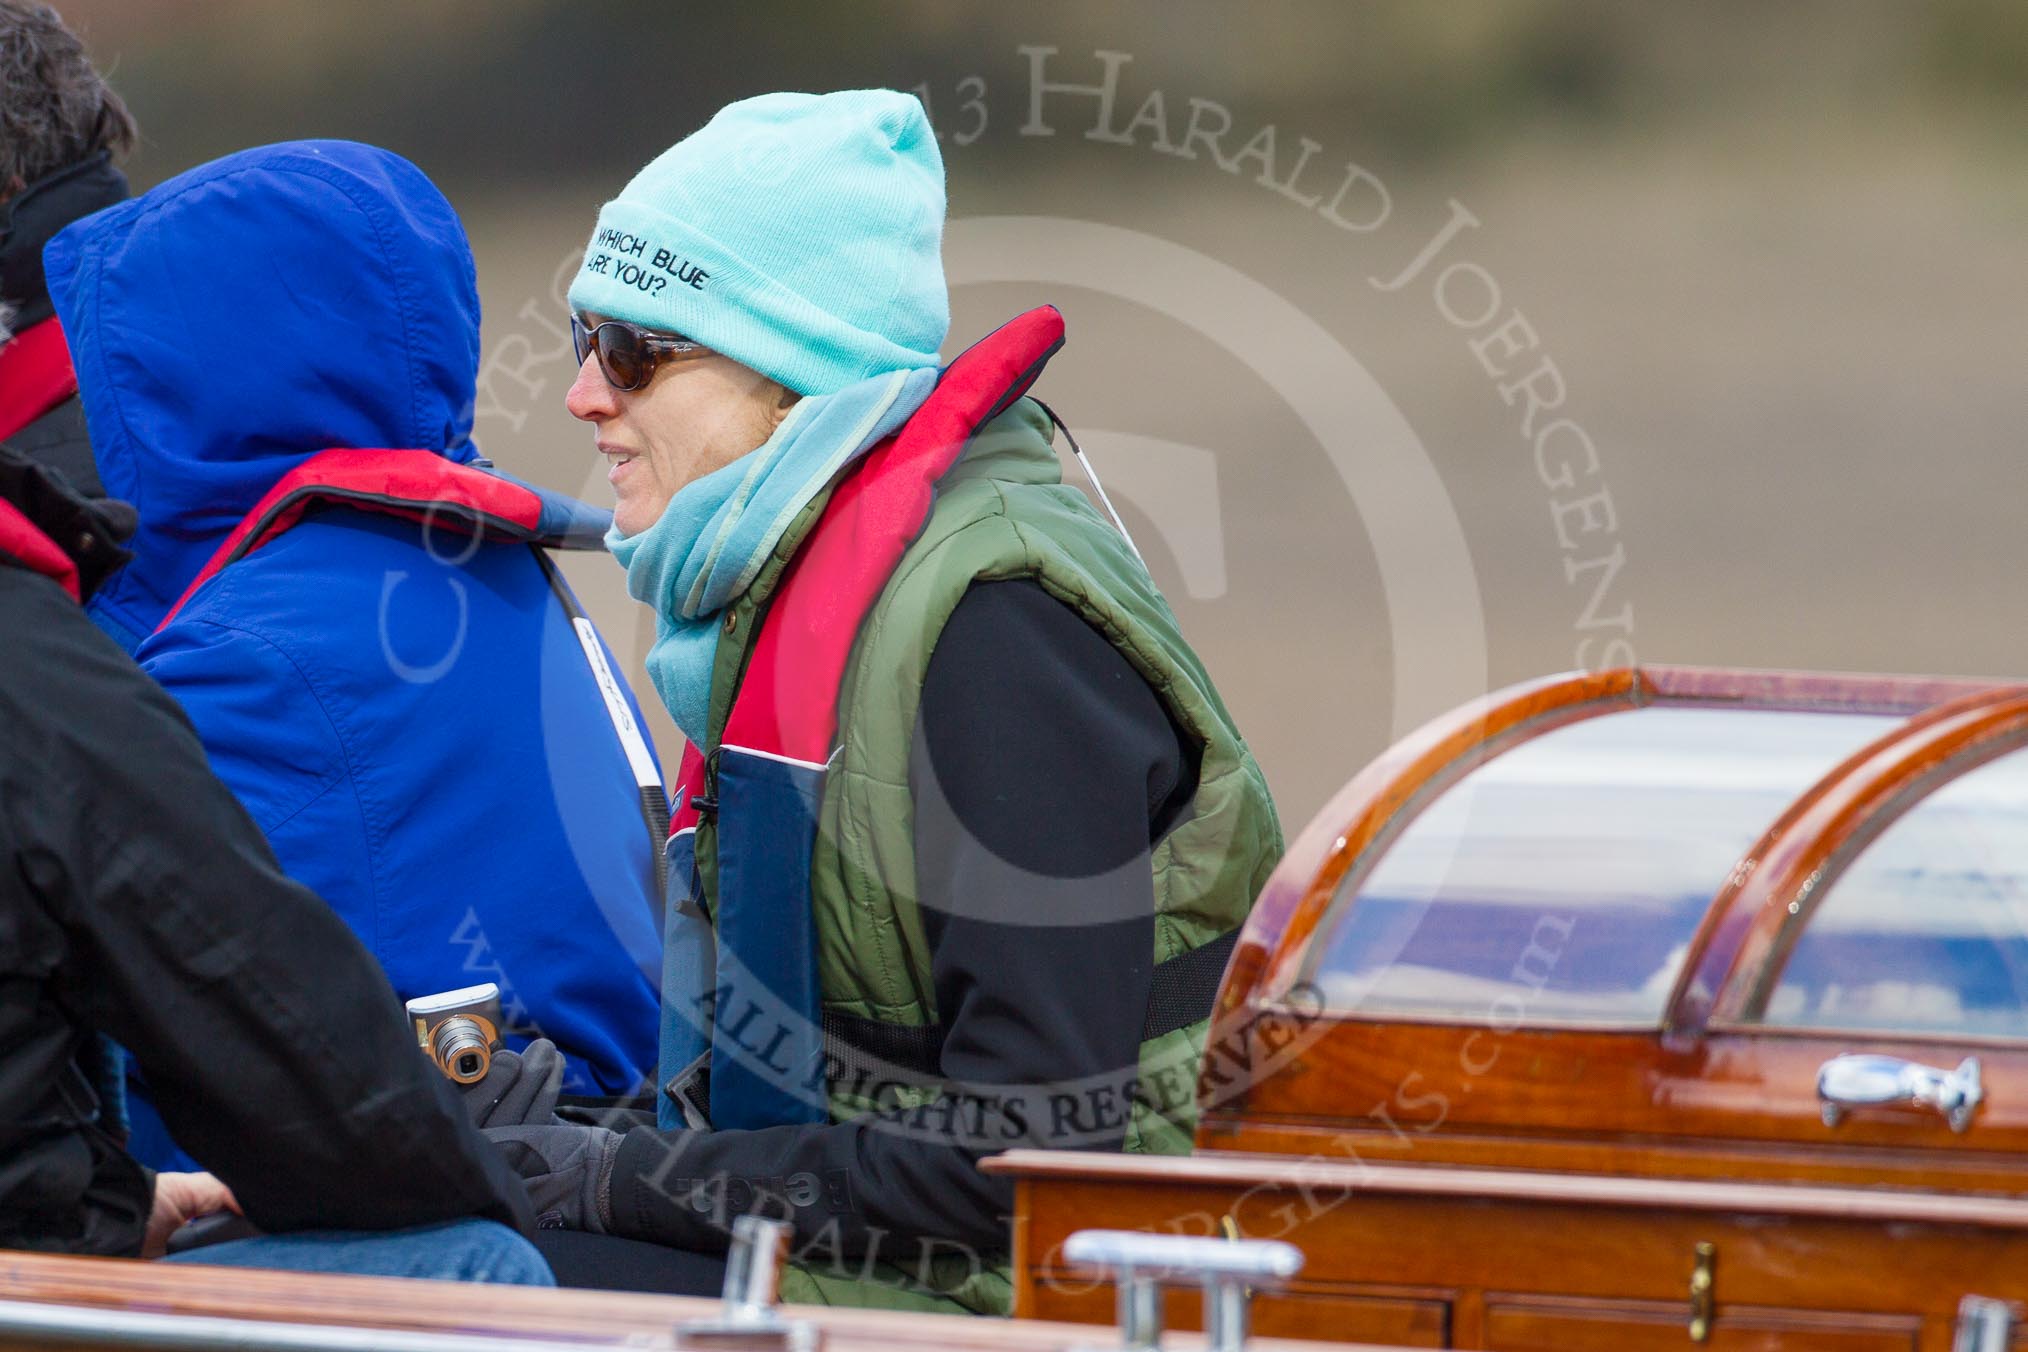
[156,450,541,630]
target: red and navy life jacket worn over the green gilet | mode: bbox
[659,306,1063,1129]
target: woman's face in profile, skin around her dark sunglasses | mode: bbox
[564,314,795,535]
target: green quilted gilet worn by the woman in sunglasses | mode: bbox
[698,399,1282,1313]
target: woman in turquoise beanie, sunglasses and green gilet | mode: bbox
[489,89,1282,1313]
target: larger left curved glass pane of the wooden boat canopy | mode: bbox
[1306,705,1902,1028]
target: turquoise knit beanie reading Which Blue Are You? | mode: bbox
[570,89,951,395]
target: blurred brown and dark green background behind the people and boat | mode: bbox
[57,0,2028,831]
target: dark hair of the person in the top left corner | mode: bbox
[0,0,140,201]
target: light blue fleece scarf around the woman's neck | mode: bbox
[606,367,937,746]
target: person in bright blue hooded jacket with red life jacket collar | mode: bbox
[45,142,667,1163]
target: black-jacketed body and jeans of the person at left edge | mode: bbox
[0,450,550,1285]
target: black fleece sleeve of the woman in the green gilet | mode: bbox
[612,580,1194,1267]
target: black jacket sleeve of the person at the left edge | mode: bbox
[0,586,529,1230]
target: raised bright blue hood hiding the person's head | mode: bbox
[43,140,479,651]
